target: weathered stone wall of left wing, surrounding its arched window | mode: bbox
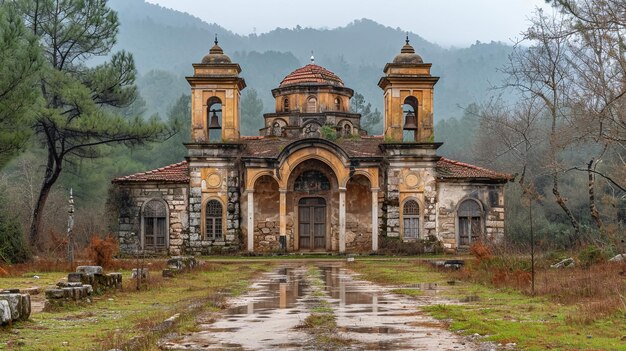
[118,183,189,255]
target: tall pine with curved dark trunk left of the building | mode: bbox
[15,0,168,245]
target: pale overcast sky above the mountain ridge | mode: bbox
[147,0,547,46]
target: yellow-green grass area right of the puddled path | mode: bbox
[351,261,626,350]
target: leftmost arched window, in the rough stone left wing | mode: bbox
[143,200,167,249]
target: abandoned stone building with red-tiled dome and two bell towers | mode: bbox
[113,39,511,254]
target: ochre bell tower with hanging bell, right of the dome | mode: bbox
[378,34,439,143]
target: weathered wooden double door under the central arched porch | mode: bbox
[298,197,326,250]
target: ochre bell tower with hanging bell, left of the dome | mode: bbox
[186,35,246,143]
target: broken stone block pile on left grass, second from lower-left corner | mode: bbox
[45,266,122,307]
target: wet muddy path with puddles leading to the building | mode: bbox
[160,262,480,350]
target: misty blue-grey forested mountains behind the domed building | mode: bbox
[110,0,511,131]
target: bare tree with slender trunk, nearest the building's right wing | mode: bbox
[504,10,580,241]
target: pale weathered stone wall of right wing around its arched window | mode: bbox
[437,182,504,250]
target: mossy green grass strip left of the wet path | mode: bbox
[0,263,271,351]
